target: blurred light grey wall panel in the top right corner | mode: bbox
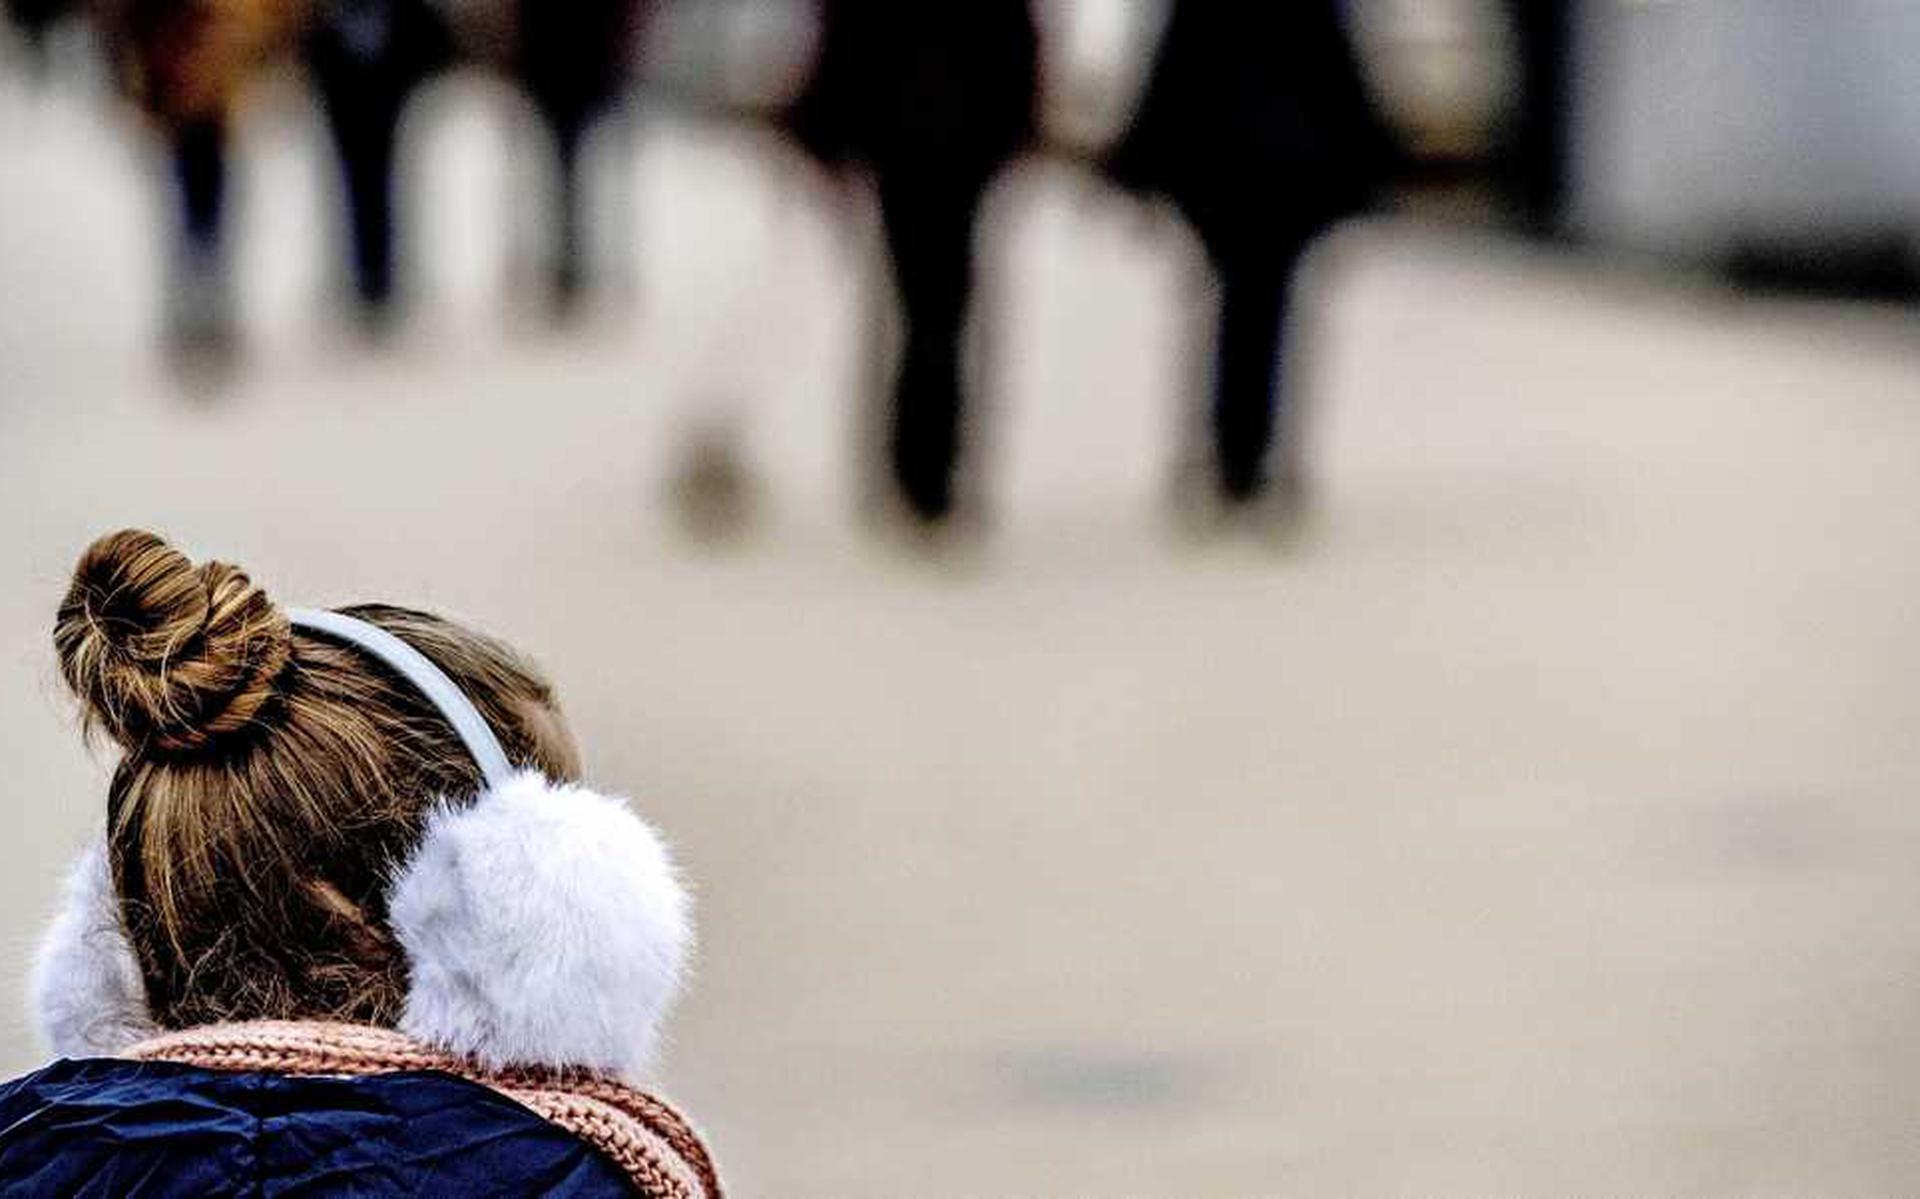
[1578,0,1920,250]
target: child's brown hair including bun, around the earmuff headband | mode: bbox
[54,530,578,1028]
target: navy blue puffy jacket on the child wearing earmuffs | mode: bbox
[0,1059,634,1199]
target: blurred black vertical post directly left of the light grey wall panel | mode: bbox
[1507,0,1574,234]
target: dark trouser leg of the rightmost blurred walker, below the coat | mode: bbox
[1212,240,1304,502]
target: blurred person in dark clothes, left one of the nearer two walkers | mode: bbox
[789,0,1039,523]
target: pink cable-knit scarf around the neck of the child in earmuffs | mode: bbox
[125,1020,722,1199]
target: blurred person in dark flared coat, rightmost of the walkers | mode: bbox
[1106,0,1390,505]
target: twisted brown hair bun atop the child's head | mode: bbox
[54,528,292,751]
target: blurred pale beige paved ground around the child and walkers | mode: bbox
[0,81,1920,1195]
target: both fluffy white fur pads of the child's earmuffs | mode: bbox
[33,772,693,1078]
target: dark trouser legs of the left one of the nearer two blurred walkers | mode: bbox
[877,163,987,521]
